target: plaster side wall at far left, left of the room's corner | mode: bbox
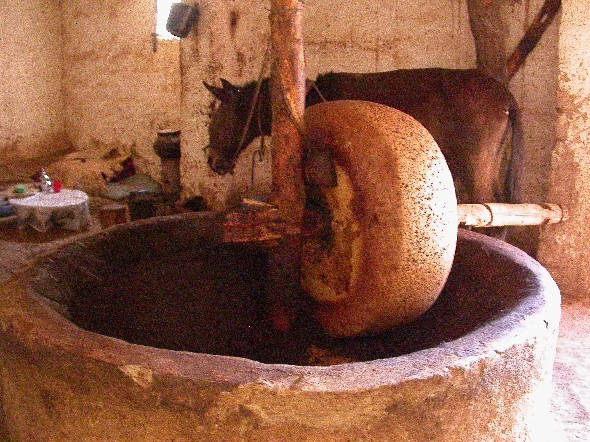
[0,0,69,163]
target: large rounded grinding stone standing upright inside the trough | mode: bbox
[302,101,457,336]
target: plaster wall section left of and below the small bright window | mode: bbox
[63,0,180,179]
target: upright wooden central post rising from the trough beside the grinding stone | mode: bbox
[268,0,305,331]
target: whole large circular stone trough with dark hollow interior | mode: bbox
[0,213,560,441]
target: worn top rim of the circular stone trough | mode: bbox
[0,214,561,391]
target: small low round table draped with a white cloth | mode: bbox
[9,189,90,232]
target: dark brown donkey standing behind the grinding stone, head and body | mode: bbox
[204,68,522,203]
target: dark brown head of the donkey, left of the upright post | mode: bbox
[203,79,270,175]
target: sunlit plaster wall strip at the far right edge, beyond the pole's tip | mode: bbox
[539,0,590,301]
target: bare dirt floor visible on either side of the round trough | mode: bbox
[0,199,590,442]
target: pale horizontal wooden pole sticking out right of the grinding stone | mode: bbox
[457,203,568,227]
